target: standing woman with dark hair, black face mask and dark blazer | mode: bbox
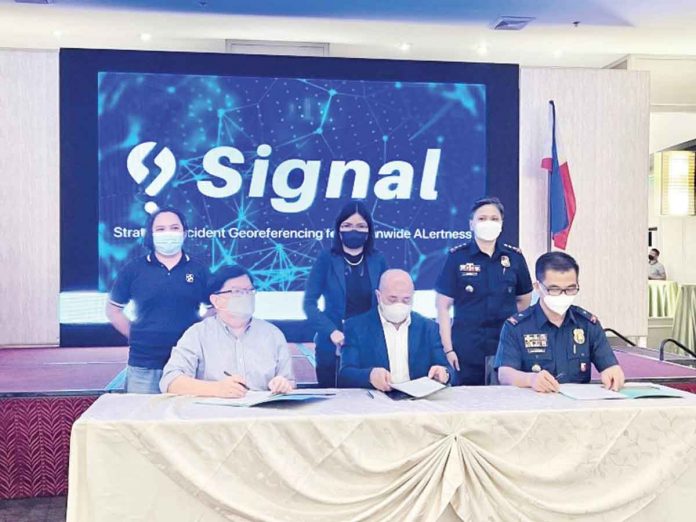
[303,201,387,388]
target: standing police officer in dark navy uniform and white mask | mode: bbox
[435,197,532,385]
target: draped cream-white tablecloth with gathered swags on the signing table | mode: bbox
[68,387,696,522]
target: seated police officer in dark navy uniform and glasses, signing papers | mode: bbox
[495,252,624,392]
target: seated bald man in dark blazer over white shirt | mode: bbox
[338,270,454,392]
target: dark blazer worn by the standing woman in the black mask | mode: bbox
[303,250,387,346]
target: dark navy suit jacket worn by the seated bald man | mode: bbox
[338,308,454,388]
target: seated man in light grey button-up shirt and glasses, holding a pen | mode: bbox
[160,266,295,398]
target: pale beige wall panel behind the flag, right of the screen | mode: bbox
[520,68,650,336]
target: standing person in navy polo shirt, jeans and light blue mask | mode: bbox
[106,209,208,393]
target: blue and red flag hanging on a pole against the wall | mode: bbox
[541,101,576,250]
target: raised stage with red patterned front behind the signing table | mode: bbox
[0,343,696,499]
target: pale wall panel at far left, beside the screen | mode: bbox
[0,50,60,345]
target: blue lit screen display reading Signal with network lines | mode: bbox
[98,72,486,291]
